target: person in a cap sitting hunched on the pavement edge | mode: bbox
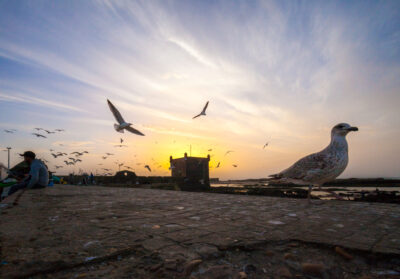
[8,151,49,196]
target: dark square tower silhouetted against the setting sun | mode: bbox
[170,153,210,190]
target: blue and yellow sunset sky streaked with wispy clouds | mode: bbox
[0,0,400,179]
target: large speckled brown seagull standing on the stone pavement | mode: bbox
[269,123,358,203]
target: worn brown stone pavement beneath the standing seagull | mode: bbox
[0,186,400,278]
